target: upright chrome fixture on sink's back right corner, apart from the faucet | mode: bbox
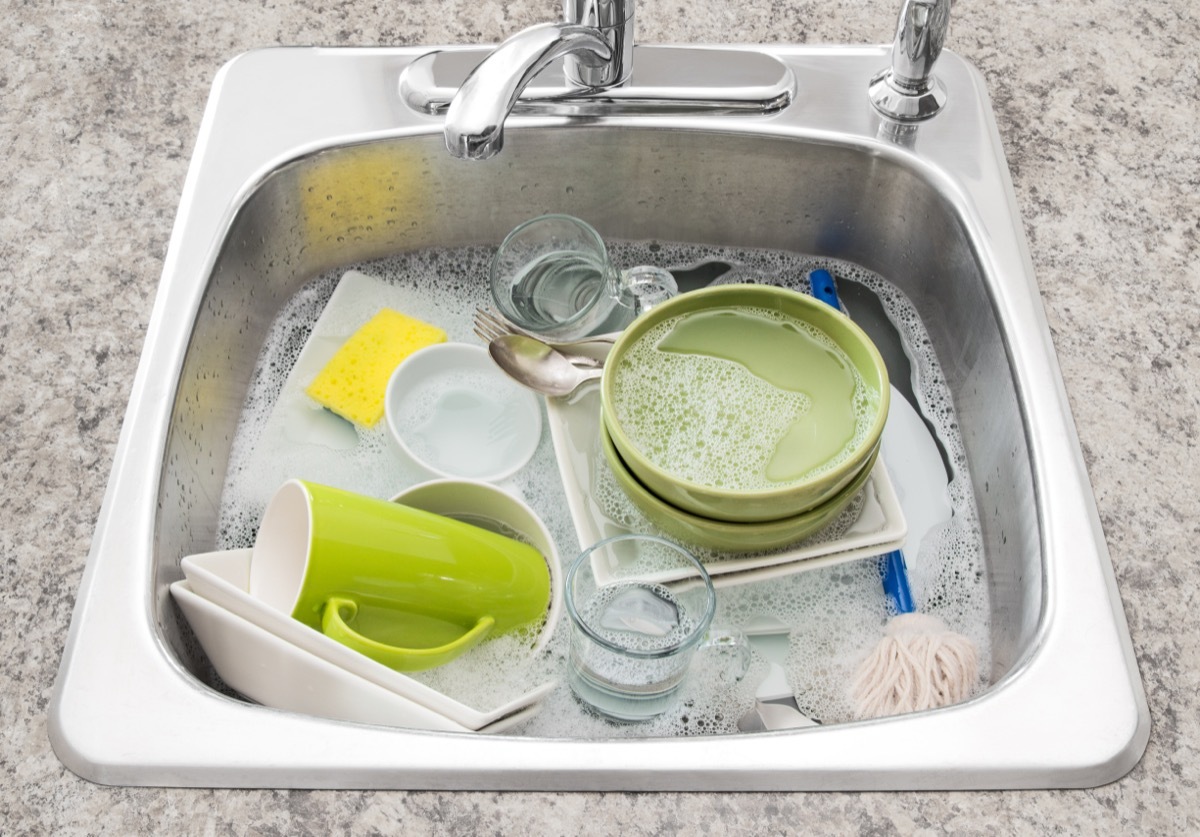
[869,0,950,122]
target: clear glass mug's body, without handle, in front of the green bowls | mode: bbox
[564,535,716,721]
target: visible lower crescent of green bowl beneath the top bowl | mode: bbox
[600,428,878,553]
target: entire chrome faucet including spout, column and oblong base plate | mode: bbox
[398,0,797,159]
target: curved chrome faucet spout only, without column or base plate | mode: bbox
[445,23,613,159]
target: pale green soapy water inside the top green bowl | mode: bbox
[617,306,878,489]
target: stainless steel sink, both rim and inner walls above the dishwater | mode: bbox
[50,46,1150,790]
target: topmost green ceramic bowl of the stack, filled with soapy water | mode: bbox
[601,284,890,523]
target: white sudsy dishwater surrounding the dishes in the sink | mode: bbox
[215,242,990,739]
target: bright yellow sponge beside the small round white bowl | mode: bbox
[305,308,446,427]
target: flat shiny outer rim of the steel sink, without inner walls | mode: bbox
[49,46,1150,790]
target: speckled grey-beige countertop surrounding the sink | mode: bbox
[0,0,1200,835]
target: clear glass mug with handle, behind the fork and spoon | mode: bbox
[488,215,679,341]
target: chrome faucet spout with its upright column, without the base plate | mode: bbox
[445,0,634,159]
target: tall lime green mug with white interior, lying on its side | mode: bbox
[250,480,551,672]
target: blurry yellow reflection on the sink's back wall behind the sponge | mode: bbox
[299,143,428,243]
